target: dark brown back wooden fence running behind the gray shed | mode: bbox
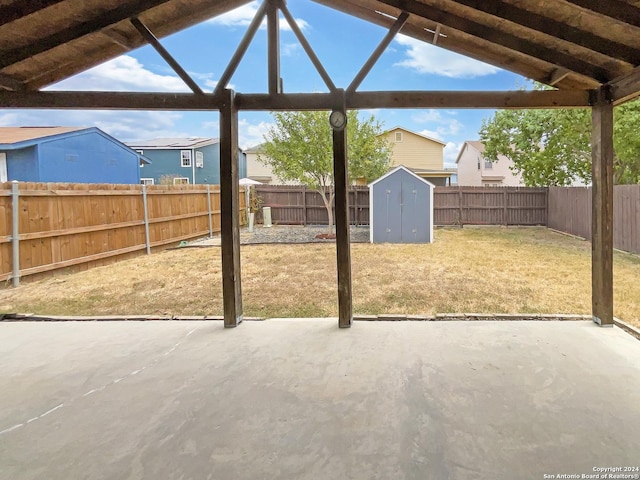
[256,185,547,225]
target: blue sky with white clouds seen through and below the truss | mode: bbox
[0,0,526,166]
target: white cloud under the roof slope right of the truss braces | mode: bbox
[396,35,500,78]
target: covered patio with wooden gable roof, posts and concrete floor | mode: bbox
[0,0,640,479]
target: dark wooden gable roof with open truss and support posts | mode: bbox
[0,0,640,327]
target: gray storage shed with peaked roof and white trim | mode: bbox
[369,166,434,243]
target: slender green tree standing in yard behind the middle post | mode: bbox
[258,110,391,231]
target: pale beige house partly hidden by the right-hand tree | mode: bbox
[456,140,524,187]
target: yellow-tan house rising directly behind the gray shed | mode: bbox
[380,127,455,186]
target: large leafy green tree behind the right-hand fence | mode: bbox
[480,86,640,186]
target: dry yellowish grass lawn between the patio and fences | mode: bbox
[0,227,640,326]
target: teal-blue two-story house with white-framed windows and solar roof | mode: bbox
[127,137,247,185]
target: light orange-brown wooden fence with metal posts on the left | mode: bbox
[0,182,245,285]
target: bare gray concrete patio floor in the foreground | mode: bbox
[0,319,640,480]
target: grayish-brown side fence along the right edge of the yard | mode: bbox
[547,185,640,254]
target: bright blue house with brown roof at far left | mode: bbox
[0,127,150,184]
